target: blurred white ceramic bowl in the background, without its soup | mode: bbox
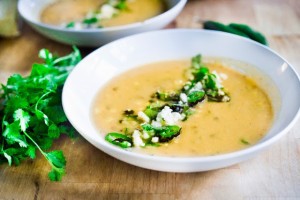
[18,0,187,47]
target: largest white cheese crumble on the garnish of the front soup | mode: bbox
[156,106,183,125]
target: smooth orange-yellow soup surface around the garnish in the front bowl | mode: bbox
[92,60,273,156]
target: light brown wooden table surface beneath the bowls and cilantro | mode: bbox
[0,0,300,200]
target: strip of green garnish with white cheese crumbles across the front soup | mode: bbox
[105,55,230,148]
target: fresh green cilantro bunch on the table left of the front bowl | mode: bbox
[0,47,81,181]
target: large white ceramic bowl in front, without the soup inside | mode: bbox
[62,29,300,172]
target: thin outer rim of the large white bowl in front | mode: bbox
[62,28,300,164]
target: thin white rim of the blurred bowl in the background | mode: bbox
[18,0,187,33]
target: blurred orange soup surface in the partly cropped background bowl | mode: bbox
[41,0,165,27]
